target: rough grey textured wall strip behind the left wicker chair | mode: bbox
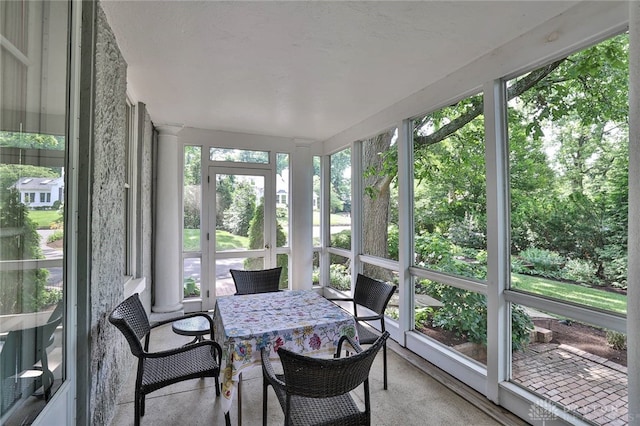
[89,7,132,425]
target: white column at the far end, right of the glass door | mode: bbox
[289,146,313,290]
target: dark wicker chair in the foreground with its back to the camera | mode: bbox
[261,332,389,426]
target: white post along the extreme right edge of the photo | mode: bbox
[627,1,640,425]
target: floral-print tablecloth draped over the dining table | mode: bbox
[214,290,357,412]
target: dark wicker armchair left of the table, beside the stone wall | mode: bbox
[109,293,222,426]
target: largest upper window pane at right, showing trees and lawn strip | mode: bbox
[507,34,629,314]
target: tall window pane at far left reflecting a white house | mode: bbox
[0,1,69,424]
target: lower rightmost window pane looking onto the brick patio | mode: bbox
[511,308,628,424]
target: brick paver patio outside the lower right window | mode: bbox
[512,343,628,426]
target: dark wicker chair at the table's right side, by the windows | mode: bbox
[330,274,396,389]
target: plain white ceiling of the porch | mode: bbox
[102,0,576,140]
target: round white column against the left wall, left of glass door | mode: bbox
[152,126,182,313]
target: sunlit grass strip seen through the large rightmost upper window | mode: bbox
[511,274,627,314]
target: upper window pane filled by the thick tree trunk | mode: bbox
[362,127,398,260]
